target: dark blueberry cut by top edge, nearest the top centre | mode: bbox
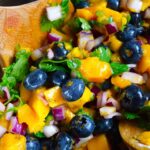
[71,0,89,9]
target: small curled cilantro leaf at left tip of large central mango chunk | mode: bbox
[67,58,81,70]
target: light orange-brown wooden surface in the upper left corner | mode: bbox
[0,0,47,66]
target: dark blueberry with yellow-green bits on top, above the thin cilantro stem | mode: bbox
[52,42,68,60]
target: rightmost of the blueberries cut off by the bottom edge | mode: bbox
[55,132,73,150]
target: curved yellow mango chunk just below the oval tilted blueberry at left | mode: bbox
[29,88,50,121]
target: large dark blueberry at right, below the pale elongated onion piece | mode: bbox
[121,85,146,112]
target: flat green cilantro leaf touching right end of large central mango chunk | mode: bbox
[110,62,129,75]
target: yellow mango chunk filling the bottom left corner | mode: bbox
[0,133,26,150]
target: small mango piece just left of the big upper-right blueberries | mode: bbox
[109,35,122,52]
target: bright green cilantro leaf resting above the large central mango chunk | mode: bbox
[90,46,111,62]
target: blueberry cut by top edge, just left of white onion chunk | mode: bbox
[107,0,120,10]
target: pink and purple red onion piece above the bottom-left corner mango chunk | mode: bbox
[10,117,27,135]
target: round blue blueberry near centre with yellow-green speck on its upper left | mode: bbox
[62,78,85,101]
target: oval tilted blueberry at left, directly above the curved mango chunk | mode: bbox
[24,69,47,90]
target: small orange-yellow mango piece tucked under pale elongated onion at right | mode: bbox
[111,76,131,89]
